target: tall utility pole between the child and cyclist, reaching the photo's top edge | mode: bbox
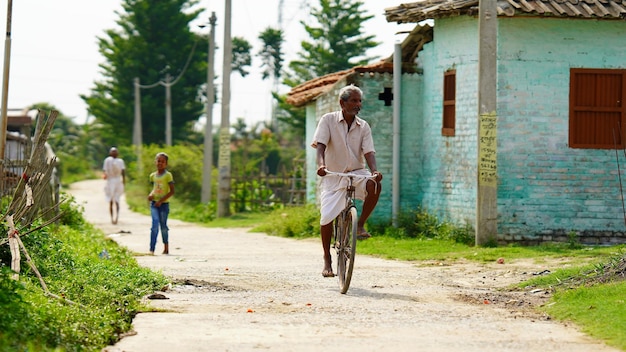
[217,0,233,217]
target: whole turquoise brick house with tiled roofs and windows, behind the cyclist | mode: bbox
[290,0,626,244]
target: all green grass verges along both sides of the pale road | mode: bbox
[0,180,626,351]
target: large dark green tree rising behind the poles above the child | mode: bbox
[81,0,207,145]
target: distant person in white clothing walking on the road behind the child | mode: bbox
[102,147,126,225]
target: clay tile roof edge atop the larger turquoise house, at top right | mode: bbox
[385,0,626,23]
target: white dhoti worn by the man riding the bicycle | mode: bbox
[320,169,371,225]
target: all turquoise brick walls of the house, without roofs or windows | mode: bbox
[307,16,626,244]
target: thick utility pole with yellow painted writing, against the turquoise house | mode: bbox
[476,0,498,245]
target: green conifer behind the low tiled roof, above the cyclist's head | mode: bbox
[285,0,380,87]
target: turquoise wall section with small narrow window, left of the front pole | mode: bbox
[416,17,478,224]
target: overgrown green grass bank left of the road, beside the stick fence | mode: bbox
[0,195,168,351]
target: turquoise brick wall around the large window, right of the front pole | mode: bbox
[498,18,626,243]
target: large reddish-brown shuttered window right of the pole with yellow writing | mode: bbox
[569,68,626,149]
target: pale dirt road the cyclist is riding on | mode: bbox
[69,180,616,352]
